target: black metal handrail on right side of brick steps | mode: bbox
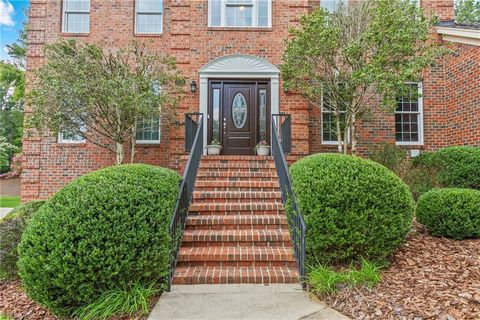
[272,114,307,289]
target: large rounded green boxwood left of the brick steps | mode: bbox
[18,165,180,315]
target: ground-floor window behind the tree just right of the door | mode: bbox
[321,86,348,144]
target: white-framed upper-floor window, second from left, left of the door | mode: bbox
[135,0,163,34]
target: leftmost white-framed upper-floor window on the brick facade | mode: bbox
[62,0,90,33]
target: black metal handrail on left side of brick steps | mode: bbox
[167,113,203,291]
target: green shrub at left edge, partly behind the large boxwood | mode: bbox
[0,201,44,279]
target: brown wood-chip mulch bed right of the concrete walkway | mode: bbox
[323,226,480,320]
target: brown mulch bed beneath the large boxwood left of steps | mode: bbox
[0,280,159,320]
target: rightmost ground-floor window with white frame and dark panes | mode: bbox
[395,83,423,145]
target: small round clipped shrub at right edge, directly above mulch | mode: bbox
[416,188,480,239]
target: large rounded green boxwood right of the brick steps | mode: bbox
[290,154,414,266]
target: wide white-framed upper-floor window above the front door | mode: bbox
[208,0,272,28]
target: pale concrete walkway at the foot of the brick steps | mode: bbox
[148,284,349,320]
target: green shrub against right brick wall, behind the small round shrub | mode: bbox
[413,146,480,190]
